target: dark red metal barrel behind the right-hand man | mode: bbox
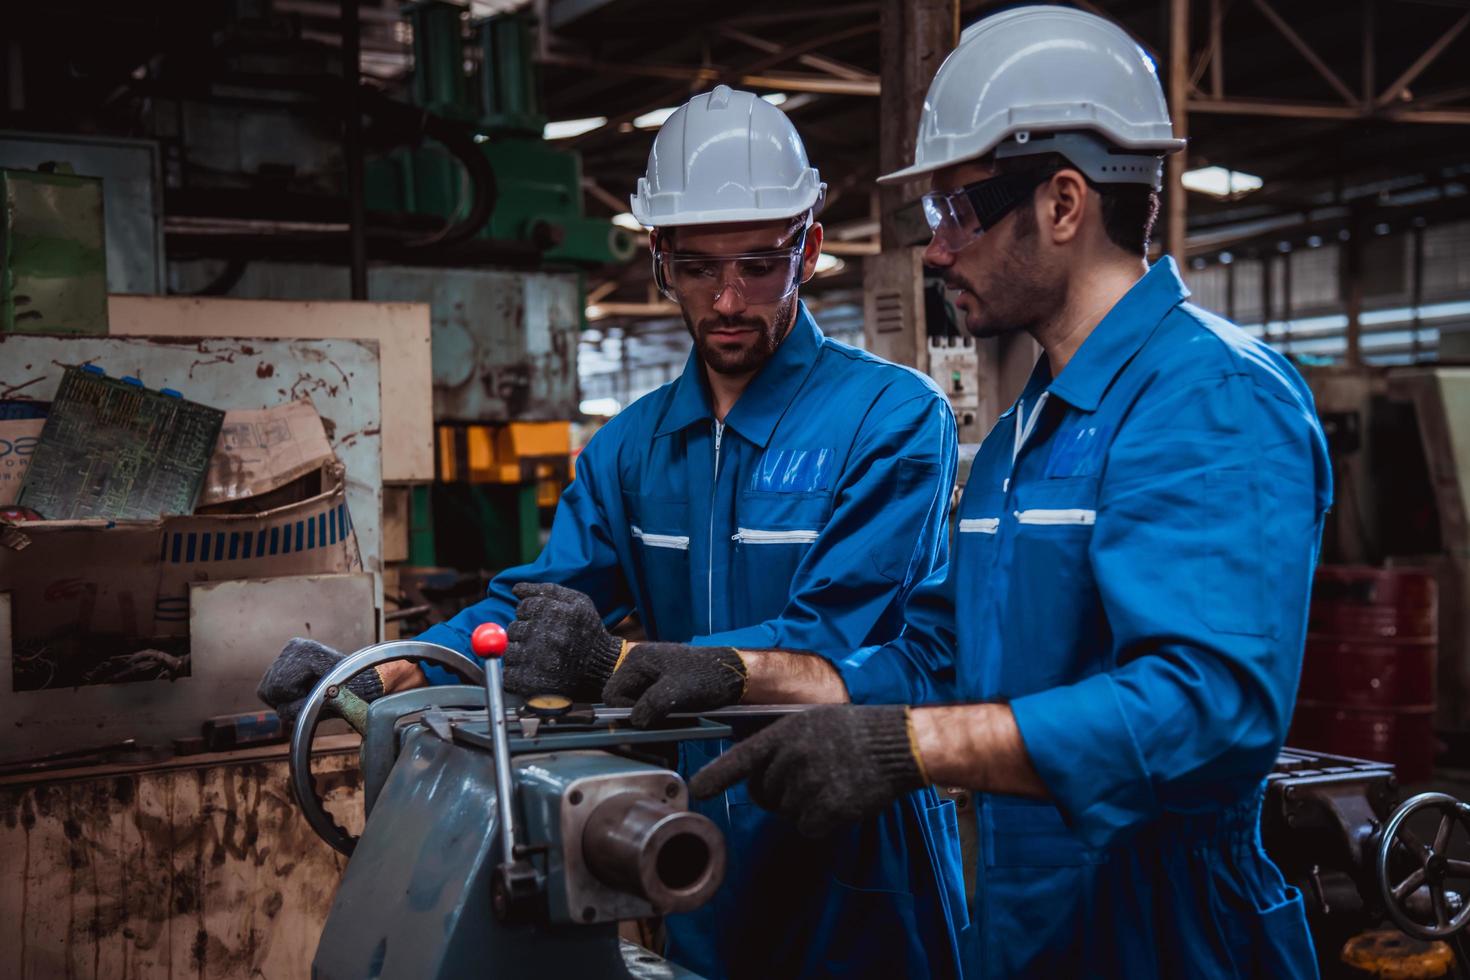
[1288,566,1439,783]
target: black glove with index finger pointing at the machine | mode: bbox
[689,704,929,837]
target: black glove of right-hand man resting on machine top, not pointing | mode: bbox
[603,642,745,729]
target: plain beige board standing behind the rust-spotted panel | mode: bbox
[107,295,434,483]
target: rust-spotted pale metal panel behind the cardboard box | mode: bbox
[0,335,382,590]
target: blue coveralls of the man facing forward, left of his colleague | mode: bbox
[422,306,966,977]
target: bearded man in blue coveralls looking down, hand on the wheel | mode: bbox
[262,85,966,979]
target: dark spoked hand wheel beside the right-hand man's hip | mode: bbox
[1374,793,1470,939]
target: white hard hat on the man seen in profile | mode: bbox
[878,6,1185,187]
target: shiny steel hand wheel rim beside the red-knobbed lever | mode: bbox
[290,639,485,855]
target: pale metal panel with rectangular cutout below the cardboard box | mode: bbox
[0,573,378,764]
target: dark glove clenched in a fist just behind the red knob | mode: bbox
[504,582,623,701]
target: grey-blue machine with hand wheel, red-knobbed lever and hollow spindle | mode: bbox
[291,640,800,980]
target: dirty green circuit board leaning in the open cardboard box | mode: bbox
[16,367,225,520]
